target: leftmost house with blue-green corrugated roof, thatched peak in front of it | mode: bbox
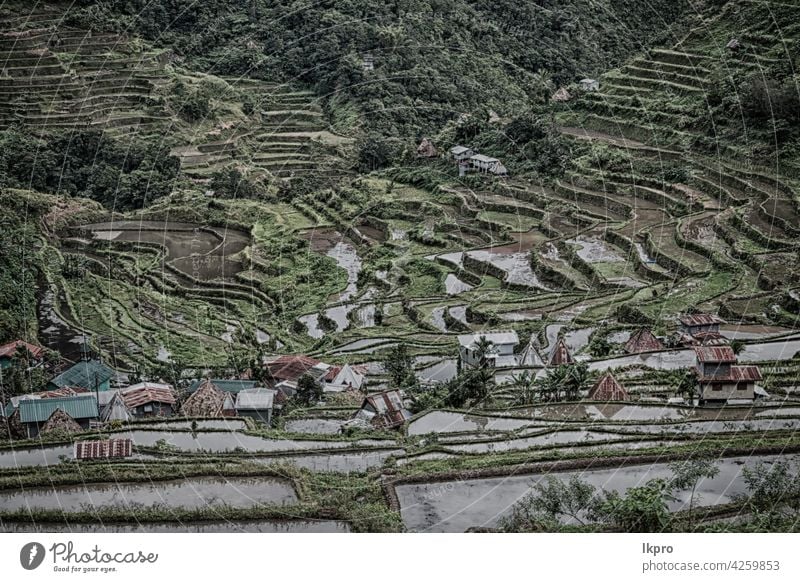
[18,394,100,438]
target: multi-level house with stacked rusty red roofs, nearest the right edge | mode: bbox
[694,346,762,404]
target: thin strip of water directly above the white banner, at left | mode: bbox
[0,520,350,533]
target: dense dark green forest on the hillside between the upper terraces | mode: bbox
[69,0,689,135]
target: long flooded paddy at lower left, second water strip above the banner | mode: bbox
[0,477,297,511]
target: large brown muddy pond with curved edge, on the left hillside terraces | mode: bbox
[81,220,250,281]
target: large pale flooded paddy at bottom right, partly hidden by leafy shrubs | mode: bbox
[397,455,798,532]
